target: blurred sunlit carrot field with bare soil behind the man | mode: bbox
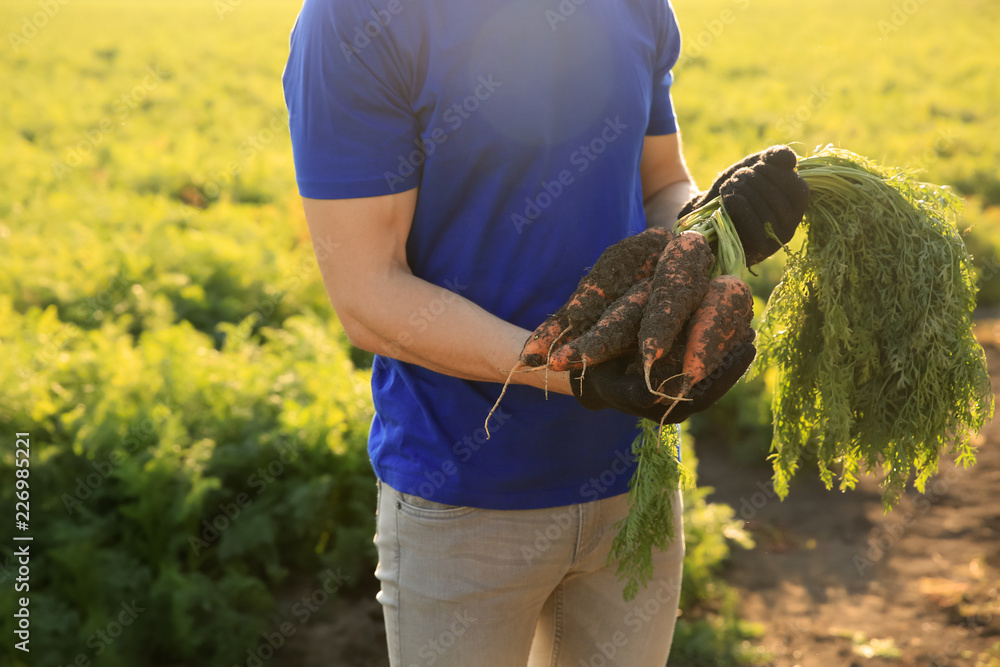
[0,0,1000,667]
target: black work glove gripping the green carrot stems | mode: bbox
[678,146,809,266]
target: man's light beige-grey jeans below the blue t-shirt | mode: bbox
[375,482,684,667]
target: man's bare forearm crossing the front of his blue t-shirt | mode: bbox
[338,269,570,394]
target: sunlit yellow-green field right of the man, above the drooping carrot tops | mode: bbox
[671,0,1000,305]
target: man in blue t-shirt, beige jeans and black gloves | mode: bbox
[283,0,802,667]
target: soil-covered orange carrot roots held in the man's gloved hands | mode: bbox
[487,228,755,430]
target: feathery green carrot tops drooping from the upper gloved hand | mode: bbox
[755,149,993,508]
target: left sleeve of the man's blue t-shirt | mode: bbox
[282,0,420,199]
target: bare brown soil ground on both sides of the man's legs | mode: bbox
[276,320,1000,667]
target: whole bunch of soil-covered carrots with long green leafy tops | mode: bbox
[487,146,994,599]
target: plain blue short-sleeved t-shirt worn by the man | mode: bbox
[283,0,680,509]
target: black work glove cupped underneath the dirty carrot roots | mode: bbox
[569,329,757,424]
